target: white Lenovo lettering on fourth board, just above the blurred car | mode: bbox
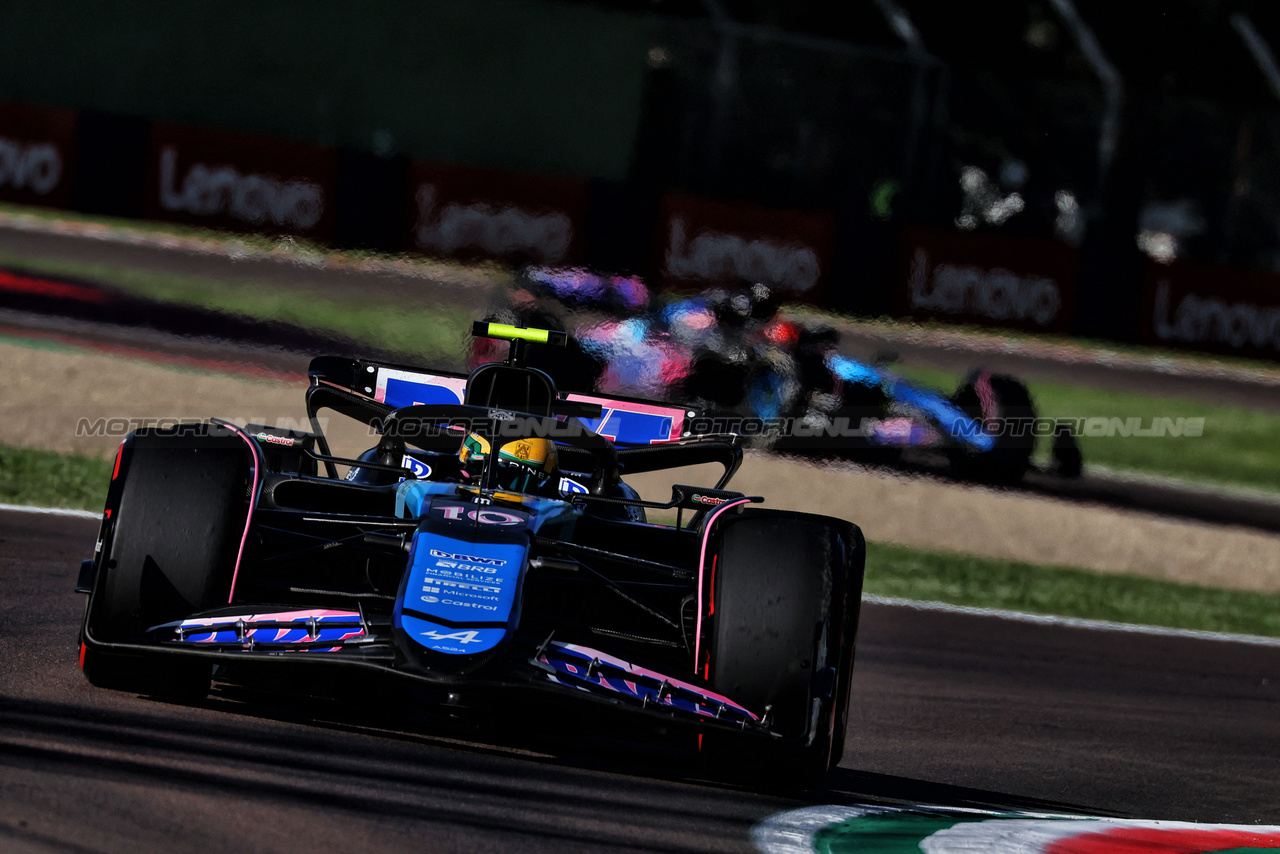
[666,216,822,291]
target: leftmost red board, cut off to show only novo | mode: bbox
[0,101,76,207]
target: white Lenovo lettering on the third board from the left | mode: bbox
[413,184,573,264]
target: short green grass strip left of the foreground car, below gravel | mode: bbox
[0,446,114,511]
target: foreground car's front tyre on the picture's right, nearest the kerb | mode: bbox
[703,510,865,789]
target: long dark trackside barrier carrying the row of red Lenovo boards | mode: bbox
[0,101,1280,360]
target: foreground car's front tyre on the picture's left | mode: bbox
[82,428,252,699]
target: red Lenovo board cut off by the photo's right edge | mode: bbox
[1139,262,1280,359]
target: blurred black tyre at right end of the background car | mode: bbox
[951,370,1036,485]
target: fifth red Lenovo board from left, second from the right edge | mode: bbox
[897,228,1079,334]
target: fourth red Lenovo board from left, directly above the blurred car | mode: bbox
[657,193,835,303]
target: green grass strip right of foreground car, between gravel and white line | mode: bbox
[864,543,1280,638]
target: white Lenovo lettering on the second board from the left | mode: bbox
[160,146,324,229]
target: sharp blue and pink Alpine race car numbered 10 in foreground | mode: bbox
[77,323,865,786]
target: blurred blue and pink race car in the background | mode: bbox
[477,268,1083,485]
